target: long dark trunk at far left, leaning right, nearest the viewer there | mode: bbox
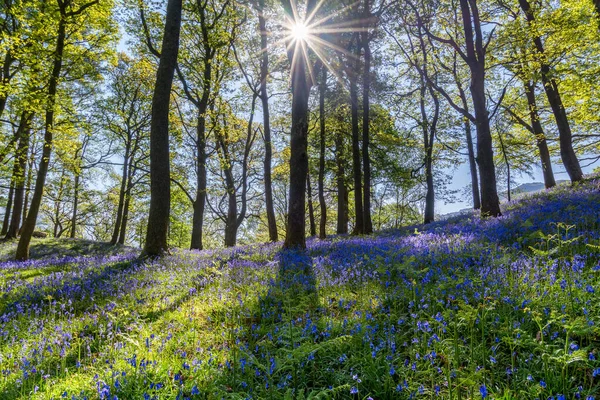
[15,13,67,261]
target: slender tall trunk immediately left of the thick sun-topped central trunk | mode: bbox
[258,0,279,242]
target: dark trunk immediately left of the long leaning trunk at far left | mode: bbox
[6,113,33,239]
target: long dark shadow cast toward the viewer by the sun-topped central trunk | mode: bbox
[209,250,322,399]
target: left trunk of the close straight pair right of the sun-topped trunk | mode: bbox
[350,70,365,235]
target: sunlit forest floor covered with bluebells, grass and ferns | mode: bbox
[0,178,600,400]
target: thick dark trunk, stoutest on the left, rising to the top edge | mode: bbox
[142,0,182,257]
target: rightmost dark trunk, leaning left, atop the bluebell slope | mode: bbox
[519,0,583,182]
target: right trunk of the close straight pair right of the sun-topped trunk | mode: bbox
[361,9,373,234]
